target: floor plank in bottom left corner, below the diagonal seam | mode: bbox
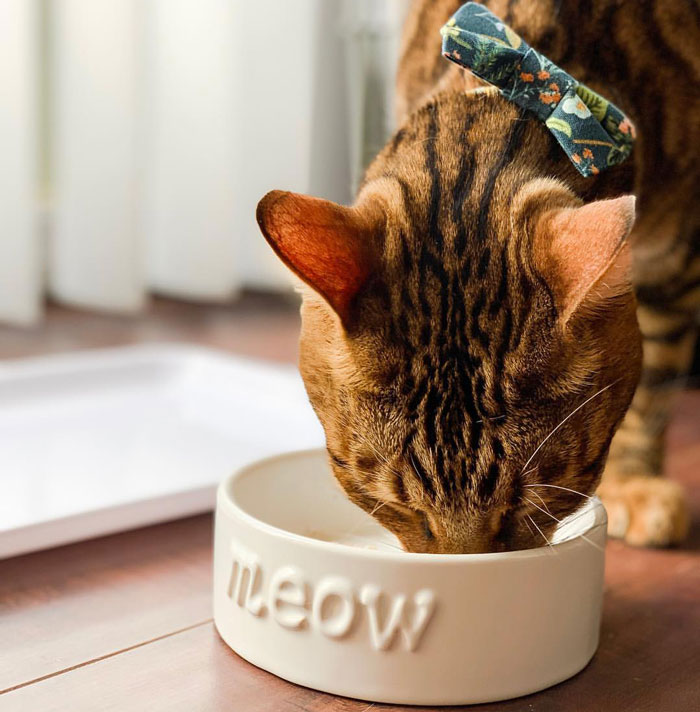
[0,623,372,712]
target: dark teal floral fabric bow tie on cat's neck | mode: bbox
[440,2,635,177]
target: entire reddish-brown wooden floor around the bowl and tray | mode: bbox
[0,299,700,712]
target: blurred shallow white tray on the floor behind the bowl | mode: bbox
[0,345,323,558]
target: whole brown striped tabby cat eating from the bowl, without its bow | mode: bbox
[257,0,700,553]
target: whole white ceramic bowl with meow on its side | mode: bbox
[214,450,606,705]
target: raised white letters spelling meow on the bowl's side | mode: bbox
[227,542,435,651]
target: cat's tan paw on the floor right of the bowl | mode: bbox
[598,475,690,546]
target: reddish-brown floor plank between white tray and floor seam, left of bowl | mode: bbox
[0,515,212,692]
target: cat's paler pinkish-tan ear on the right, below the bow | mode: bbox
[537,195,635,323]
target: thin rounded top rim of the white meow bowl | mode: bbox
[216,447,608,566]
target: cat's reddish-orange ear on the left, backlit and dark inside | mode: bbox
[257,190,376,325]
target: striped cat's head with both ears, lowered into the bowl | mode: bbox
[258,94,640,553]
